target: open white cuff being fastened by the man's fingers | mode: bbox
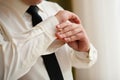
[34,16,64,54]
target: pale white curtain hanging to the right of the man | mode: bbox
[72,0,120,80]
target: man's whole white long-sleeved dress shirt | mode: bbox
[0,0,97,80]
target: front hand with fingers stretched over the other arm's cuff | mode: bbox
[56,21,90,52]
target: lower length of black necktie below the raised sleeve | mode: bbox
[42,53,64,80]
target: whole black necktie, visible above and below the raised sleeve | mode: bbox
[26,5,64,80]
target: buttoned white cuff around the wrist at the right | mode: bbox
[71,44,97,69]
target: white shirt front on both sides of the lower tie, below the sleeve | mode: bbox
[20,49,72,80]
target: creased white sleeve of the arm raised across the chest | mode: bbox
[0,16,64,80]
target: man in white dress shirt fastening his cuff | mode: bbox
[0,0,97,80]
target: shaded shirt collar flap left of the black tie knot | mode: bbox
[2,0,29,16]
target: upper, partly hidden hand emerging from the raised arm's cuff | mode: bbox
[55,10,80,24]
